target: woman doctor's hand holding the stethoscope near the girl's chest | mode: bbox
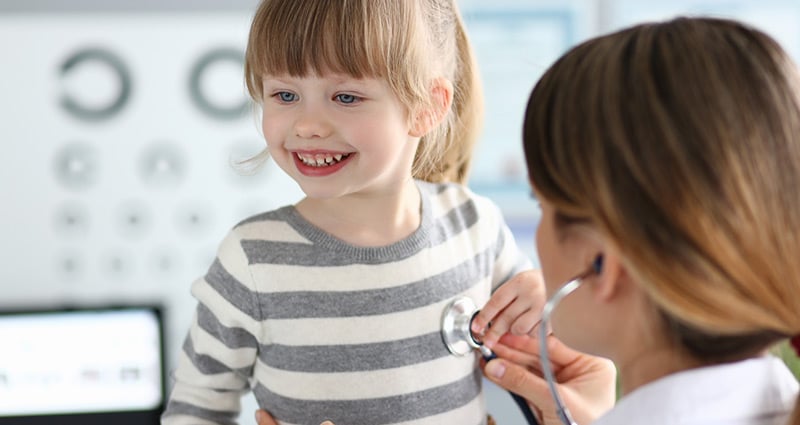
[483,334,617,425]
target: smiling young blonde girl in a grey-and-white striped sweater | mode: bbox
[163,0,535,425]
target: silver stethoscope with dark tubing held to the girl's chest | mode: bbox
[442,255,603,425]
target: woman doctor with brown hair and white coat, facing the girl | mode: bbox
[481,18,800,425]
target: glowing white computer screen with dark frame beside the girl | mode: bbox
[0,306,165,424]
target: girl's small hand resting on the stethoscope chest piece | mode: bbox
[472,270,546,349]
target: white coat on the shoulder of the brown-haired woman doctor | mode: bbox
[593,356,798,425]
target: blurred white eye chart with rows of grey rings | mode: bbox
[0,11,300,350]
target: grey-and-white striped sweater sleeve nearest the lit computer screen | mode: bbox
[161,230,261,425]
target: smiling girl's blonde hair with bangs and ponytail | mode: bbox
[245,0,483,183]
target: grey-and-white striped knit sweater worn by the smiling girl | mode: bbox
[162,182,530,425]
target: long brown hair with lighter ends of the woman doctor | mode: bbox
[523,18,800,424]
